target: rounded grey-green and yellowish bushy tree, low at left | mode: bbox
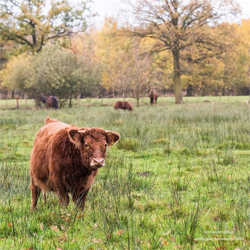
[1,45,100,106]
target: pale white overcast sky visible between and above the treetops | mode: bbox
[91,0,250,28]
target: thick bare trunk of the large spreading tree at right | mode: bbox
[172,49,182,104]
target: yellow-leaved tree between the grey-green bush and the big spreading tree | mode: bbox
[96,19,151,106]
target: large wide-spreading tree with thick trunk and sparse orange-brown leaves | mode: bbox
[128,0,241,104]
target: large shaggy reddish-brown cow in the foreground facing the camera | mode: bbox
[30,118,120,209]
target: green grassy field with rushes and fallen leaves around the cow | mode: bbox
[0,97,250,250]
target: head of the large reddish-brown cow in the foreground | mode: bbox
[68,128,120,170]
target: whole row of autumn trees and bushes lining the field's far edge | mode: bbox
[0,0,250,106]
